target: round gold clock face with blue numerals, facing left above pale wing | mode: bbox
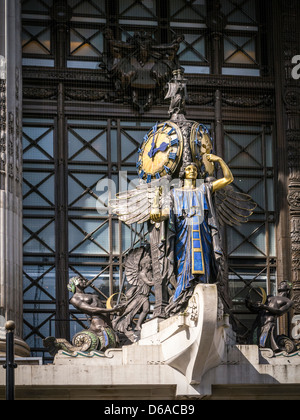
[137,121,183,182]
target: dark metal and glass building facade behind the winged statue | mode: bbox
[0,0,300,370]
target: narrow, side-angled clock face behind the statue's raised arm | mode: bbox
[190,123,214,175]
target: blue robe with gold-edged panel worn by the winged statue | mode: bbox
[169,183,222,301]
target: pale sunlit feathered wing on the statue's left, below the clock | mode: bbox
[109,179,168,225]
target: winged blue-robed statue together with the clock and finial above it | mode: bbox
[109,68,256,317]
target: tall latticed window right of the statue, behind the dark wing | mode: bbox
[224,125,276,332]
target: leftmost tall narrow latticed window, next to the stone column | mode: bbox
[23,118,56,356]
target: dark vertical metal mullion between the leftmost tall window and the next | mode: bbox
[52,0,70,340]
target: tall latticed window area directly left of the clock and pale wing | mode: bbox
[68,119,148,334]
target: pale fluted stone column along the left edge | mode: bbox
[0,0,29,356]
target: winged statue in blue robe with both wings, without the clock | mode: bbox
[110,149,256,315]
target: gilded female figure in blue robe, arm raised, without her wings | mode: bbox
[150,154,233,312]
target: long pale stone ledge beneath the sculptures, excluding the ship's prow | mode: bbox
[0,345,300,399]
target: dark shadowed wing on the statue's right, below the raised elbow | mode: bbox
[215,185,256,226]
